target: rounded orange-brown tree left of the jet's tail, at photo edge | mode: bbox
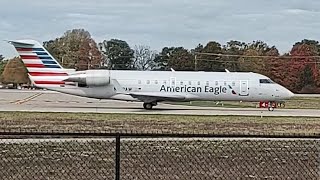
[1,57,30,87]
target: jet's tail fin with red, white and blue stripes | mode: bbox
[8,40,75,89]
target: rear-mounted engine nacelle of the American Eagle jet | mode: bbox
[65,70,110,86]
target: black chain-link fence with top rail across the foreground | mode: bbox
[0,132,320,180]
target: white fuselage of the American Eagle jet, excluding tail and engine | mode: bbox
[45,70,293,101]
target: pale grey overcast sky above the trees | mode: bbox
[0,0,320,57]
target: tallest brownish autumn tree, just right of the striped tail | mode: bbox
[44,29,103,70]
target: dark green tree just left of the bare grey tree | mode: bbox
[99,39,134,70]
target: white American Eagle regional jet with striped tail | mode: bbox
[9,40,293,110]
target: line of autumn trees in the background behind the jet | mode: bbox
[0,29,320,93]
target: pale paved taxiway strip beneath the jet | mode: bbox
[0,90,320,117]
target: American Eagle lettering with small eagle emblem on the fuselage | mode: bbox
[160,85,237,95]
